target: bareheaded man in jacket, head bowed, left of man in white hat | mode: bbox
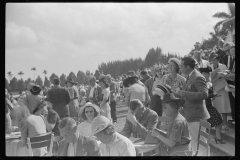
[57,117,101,157]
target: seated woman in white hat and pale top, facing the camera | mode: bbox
[77,102,99,137]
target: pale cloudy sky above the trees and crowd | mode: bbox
[5,3,228,80]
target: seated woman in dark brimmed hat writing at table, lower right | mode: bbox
[152,93,191,156]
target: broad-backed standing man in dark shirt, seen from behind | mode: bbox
[47,78,70,119]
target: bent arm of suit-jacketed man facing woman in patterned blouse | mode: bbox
[178,76,208,100]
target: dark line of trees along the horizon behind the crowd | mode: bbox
[5,47,181,92]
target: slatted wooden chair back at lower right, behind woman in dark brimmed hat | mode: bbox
[195,120,211,155]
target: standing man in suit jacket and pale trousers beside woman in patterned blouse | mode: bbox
[177,57,210,151]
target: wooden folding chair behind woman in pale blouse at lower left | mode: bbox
[26,132,54,157]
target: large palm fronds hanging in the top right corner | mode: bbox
[213,3,235,36]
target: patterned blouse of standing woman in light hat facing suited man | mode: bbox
[162,74,187,92]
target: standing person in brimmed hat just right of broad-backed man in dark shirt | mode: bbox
[65,77,79,118]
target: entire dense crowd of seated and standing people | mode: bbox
[5,42,235,156]
